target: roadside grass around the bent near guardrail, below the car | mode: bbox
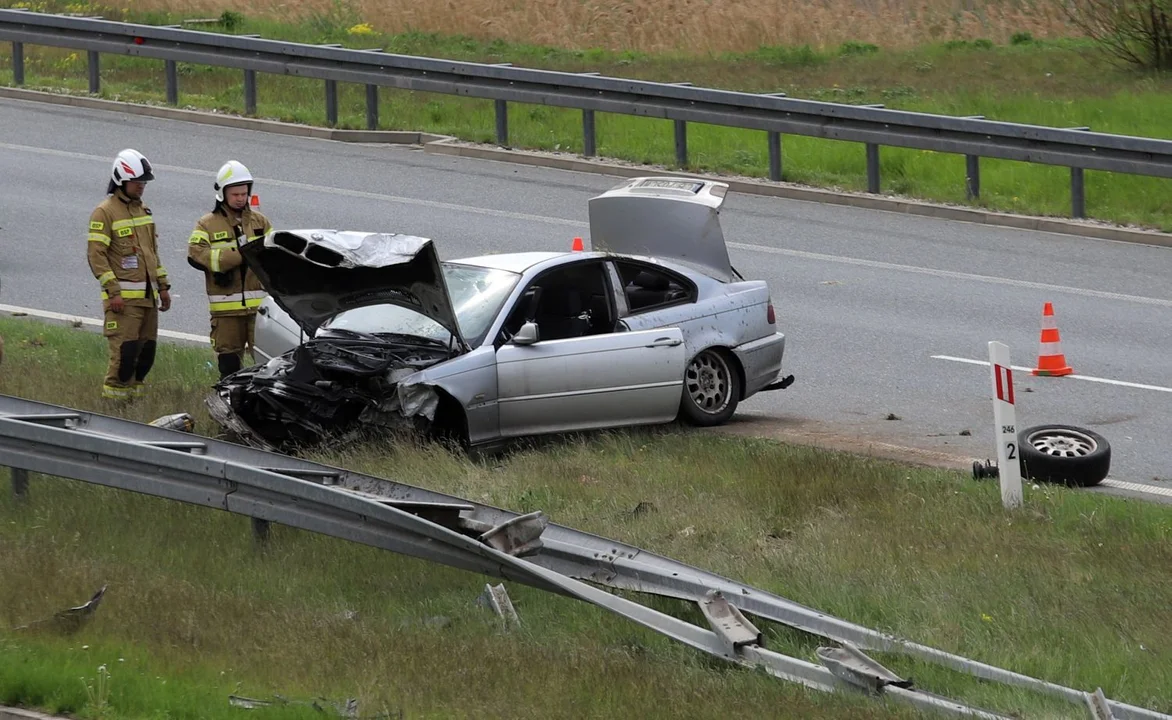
[0,319,1172,720]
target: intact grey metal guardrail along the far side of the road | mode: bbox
[0,9,1172,217]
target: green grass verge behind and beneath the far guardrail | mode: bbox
[0,4,1172,230]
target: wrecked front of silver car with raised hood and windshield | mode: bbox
[207,230,519,453]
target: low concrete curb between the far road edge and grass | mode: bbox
[0,87,1172,247]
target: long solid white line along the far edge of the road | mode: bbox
[0,143,1172,307]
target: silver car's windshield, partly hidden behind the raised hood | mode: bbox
[322,263,520,347]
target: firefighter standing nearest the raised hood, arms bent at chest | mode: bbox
[188,159,272,378]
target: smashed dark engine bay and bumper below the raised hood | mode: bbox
[207,333,450,453]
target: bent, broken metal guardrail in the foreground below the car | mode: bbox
[0,395,1172,720]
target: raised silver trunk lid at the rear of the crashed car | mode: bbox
[590,177,734,283]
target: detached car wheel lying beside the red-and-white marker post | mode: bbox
[1017,424,1111,488]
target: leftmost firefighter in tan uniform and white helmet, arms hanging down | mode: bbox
[86,149,171,400]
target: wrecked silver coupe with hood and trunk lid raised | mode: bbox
[209,177,793,451]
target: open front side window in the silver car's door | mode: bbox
[500,261,618,342]
